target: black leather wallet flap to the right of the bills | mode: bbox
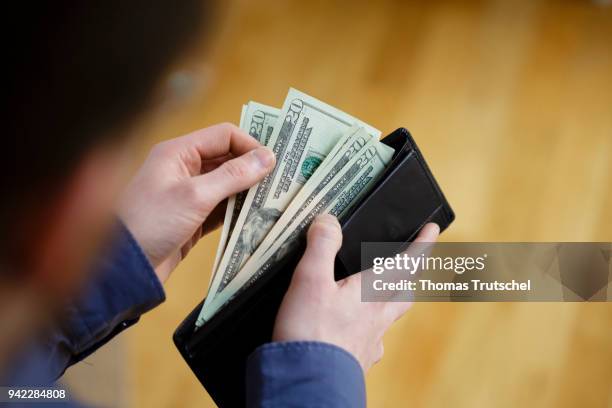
[335,128,455,280]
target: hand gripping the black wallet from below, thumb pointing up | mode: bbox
[272,215,440,372]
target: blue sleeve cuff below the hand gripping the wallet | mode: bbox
[246,342,366,408]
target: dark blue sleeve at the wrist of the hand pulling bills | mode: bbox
[41,223,165,381]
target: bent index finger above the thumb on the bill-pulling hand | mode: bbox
[175,123,261,160]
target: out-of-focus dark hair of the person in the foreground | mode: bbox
[0,0,210,268]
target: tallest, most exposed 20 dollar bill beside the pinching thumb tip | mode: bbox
[205,89,380,307]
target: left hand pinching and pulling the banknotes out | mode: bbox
[119,123,275,282]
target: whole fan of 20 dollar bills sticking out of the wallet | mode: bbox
[196,89,394,327]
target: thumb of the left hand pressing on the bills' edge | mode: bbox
[191,147,276,214]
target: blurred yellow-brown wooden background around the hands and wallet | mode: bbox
[67,0,612,407]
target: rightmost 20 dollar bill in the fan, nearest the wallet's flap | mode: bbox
[201,138,394,321]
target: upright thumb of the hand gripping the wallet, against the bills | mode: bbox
[293,214,342,283]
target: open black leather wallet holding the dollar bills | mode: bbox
[174,128,455,407]
